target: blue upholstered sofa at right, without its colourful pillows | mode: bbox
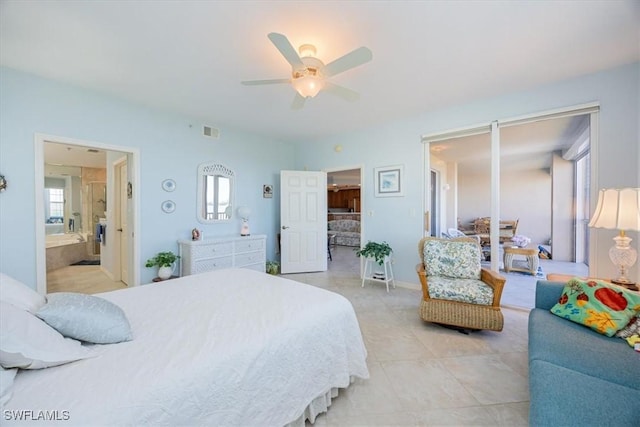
[529,280,640,427]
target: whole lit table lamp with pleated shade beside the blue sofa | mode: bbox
[589,188,640,289]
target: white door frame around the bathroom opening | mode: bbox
[34,133,140,295]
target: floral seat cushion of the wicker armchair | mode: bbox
[428,276,493,305]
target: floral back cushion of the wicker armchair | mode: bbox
[424,240,482,283]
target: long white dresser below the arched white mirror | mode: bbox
[178,234,267,276]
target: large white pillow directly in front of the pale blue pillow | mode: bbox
[0,301,95,369]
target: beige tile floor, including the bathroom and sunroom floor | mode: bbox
[47,246,585,427]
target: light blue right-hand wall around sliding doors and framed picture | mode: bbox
[296,63,640,284]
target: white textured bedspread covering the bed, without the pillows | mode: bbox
[3,269,369,426]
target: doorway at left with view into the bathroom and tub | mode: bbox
[35,135,139,293]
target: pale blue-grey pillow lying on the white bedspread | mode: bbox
[36,292,133,344]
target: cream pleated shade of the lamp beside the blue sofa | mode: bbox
[589,188,640,231]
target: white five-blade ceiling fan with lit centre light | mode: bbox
[242,33,373,110]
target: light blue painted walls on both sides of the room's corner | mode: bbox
[0,63,640,288]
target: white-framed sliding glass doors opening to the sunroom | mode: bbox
[422,104,598,270]
